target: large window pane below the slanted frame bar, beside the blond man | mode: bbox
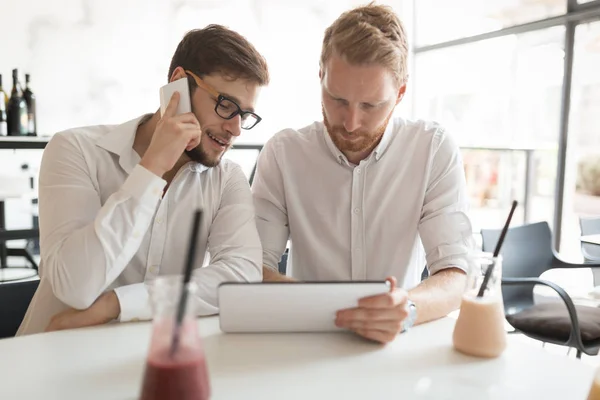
[414,26,565,231]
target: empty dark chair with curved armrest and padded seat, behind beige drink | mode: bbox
[481,222,600,358]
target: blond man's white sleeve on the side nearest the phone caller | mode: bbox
[252,136,290,271]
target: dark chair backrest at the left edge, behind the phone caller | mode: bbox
[0,279,40,338]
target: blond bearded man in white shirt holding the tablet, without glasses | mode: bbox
[252,4,472,342]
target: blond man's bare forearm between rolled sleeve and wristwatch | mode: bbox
[408,268,467,324]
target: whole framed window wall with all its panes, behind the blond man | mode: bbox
[411,0,600,268]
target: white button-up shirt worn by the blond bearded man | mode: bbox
[252,118,473,289]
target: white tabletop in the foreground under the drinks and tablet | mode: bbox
[0,317,594,400]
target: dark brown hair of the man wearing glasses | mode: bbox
[168,24,269,87]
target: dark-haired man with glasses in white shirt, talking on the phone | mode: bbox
[19,25,269,334]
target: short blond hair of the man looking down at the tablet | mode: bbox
[320,3,408,86]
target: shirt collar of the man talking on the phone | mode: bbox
[96,114,208,173]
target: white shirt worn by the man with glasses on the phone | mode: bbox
[19,118,262,334]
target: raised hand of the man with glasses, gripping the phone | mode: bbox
[140,78,202,177]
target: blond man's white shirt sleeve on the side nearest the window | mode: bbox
[419,128,474,275]
